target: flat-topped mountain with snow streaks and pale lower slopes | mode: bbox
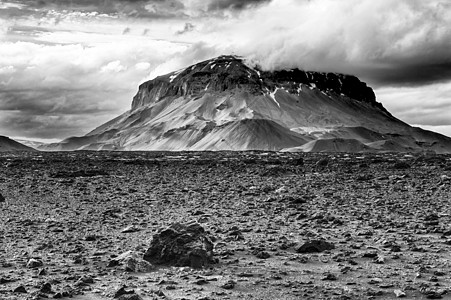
[40,56,451,153]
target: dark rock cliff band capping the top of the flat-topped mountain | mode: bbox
[132,56,382,110]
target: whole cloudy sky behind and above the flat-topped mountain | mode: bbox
[0,0,451,140]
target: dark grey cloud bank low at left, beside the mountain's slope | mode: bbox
[0,89,130,139]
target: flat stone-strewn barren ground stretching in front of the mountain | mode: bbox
[0,152,451,300]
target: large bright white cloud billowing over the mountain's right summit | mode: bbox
[179,0,451,82]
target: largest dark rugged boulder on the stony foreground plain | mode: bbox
[143,223,213,268]
